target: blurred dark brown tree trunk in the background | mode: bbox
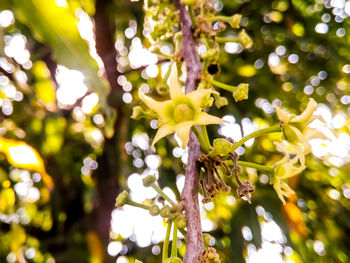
[90,0,123,262]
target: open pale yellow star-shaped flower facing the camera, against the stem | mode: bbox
[139,63,224,151]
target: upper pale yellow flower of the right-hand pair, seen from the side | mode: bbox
[275,98,324,155]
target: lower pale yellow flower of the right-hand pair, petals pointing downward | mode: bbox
[271,143,306,205]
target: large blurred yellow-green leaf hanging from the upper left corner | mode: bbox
[10,0,108,97]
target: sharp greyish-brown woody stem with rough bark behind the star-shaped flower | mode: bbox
[175,0,204,263]
